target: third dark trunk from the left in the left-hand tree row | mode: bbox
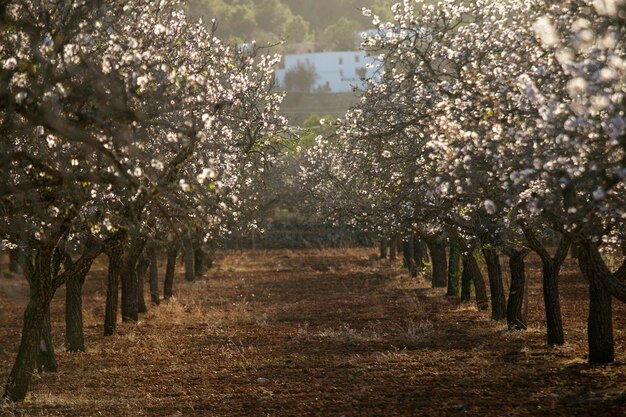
[65,266,87,352]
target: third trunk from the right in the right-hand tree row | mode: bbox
[506,250,528,330]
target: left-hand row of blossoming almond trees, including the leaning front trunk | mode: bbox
[0,0,286,401]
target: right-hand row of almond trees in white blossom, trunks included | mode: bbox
[302,0,626,363]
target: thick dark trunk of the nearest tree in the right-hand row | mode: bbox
[578,242,615,363]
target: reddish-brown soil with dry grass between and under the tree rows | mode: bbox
[0,249,626,417]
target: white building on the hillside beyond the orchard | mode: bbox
[276,51,381,93]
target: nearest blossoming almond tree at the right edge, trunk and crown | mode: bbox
[504,1,626,363]
